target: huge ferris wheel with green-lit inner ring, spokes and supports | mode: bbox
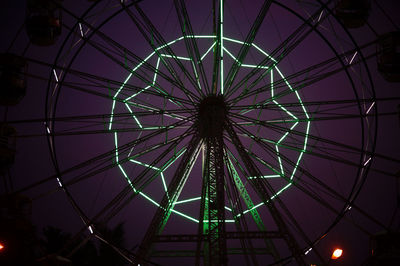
[0,0,400,265]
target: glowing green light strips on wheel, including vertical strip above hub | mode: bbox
[108,34,310,223]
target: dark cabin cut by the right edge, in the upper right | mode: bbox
[377,31,400,82]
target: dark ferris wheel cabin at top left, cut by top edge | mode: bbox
[25,0,62,46]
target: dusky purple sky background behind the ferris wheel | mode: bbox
[0,0,400,265]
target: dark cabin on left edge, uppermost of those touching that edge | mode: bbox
[0,53,27,106]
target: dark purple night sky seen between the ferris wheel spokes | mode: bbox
[0,0,400,265]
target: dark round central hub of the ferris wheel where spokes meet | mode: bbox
[198,95,227,138]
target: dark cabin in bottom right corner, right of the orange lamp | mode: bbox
[367,232,400,266]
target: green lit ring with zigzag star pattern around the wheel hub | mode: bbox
[108,35,311,223]
